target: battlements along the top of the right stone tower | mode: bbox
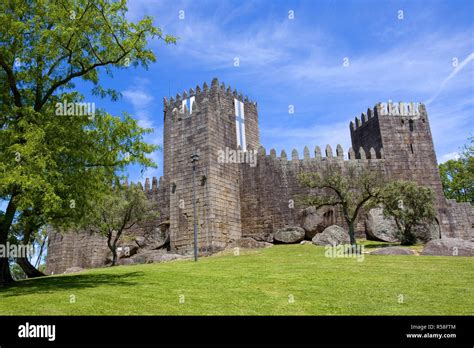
[350,100,426,130]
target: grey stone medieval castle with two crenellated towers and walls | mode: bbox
[47,79,474,273]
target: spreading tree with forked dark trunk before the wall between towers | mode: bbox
[298,165,382,245]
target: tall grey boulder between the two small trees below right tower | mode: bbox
[365,208,400,243]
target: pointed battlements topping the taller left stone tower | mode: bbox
[163,78,257,112]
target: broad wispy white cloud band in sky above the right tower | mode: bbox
[282,33,472,96]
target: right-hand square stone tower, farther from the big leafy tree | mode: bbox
[350,101,456,237]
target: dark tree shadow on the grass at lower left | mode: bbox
[0,272,143,297]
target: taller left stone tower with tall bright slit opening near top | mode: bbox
[164,79,260,253]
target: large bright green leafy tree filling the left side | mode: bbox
[0,0,175,286]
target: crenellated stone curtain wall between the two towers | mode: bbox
[240,145,385,240]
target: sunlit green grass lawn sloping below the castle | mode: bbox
[0,243,474,315]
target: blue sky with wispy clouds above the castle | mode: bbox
[78,0,474,181]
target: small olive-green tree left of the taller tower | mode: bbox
[84,185,156,266]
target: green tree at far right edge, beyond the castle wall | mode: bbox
[439,137,474,204]
